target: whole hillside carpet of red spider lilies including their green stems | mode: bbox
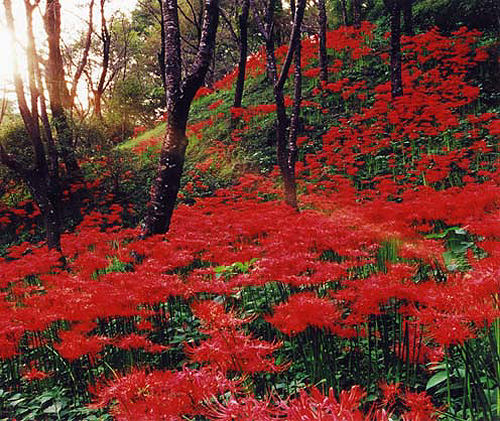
[0,22,500,421]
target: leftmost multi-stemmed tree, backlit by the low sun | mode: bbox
[0,0,63,250]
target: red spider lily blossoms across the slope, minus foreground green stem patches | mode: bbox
[0,22,500,421]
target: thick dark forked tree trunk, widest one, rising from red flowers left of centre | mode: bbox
[143,0,219,237]
